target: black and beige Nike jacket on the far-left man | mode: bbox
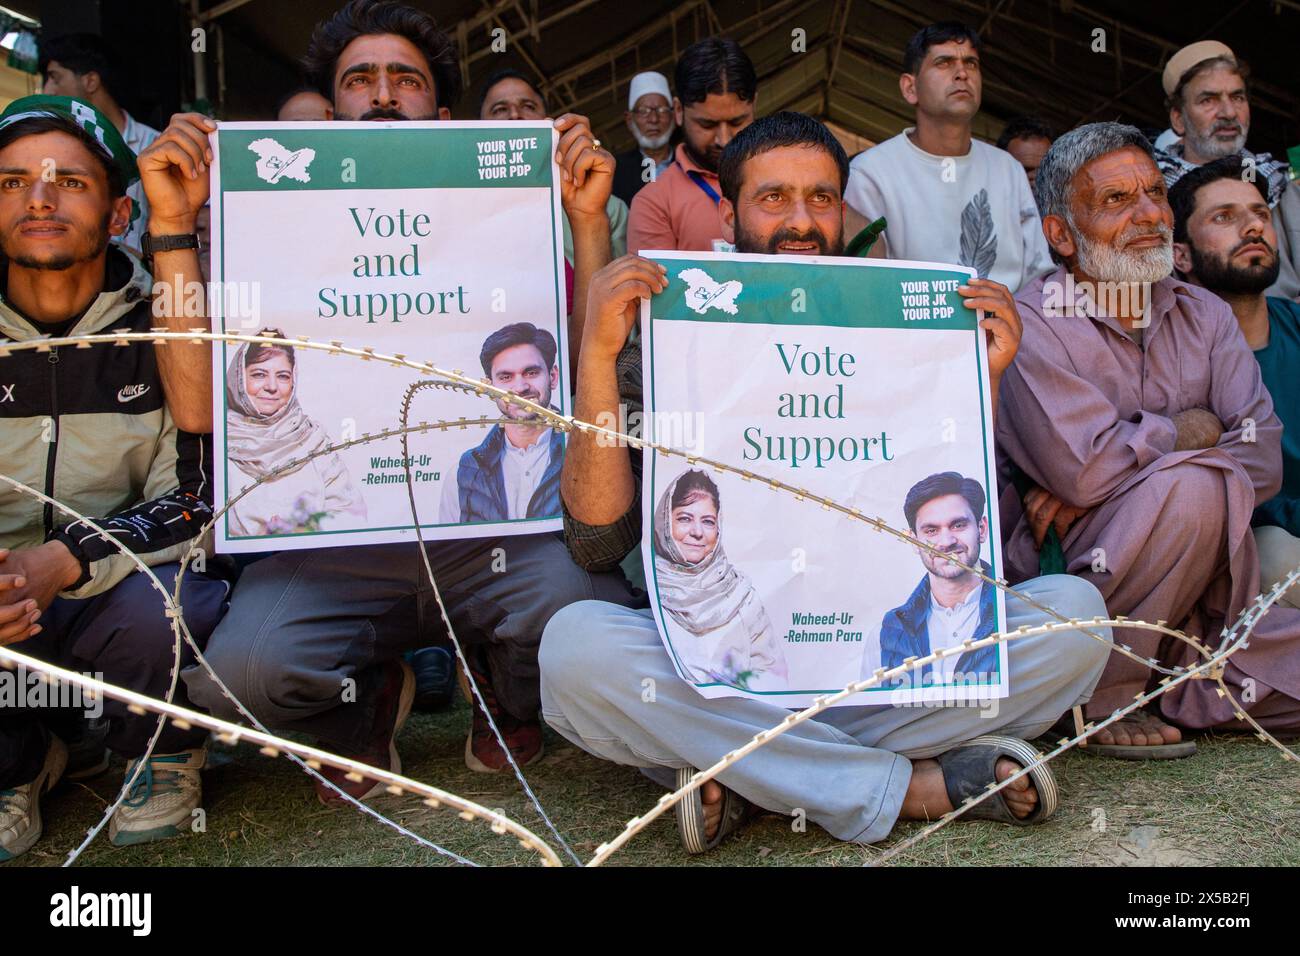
[0,246,212,598]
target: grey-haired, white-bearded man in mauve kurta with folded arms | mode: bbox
[997,122,1300,760]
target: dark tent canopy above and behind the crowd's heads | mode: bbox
[20,0,1300,153]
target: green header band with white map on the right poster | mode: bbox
[649,255,976,332]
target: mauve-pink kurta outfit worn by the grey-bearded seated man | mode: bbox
[997,268,1300,728]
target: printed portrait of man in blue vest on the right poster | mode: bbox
[880,471,997,685]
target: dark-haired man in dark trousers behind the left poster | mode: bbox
[179,0,631,785]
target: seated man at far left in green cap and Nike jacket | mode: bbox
[0,96,226,861]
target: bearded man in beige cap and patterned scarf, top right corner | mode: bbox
[1156,40,1300,300]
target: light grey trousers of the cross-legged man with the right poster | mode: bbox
[541,575,1110,843]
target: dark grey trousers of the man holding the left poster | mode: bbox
[182,535,632,752]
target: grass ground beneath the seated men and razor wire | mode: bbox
[9,702,1300,866]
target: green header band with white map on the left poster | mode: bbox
[217,124,553,193]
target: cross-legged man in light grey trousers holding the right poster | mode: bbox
[541,112,1109,852]
